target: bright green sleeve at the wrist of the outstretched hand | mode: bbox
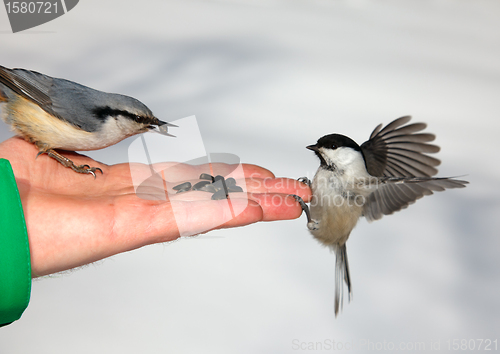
[0,159,31,327]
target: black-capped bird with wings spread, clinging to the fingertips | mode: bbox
[295,116,469,316]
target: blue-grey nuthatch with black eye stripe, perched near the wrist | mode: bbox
[0,66,175,177]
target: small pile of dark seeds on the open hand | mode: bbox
[173,173,243,200]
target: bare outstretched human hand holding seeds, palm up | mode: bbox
[0,137,311,277]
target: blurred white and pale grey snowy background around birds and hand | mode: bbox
[0,0,500,354]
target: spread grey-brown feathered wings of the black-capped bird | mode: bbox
[361,116,468,221]
